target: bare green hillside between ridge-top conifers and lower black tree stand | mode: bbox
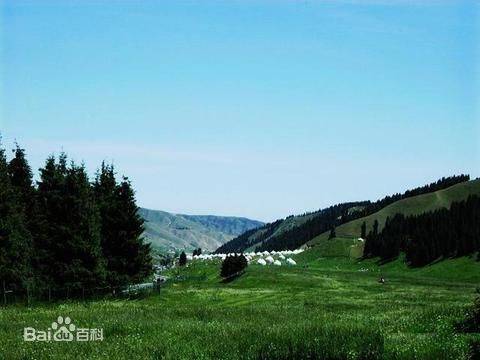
[306,179,480,257]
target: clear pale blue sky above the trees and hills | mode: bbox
[0,0,480,220]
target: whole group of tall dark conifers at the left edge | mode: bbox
[0,145,152,291]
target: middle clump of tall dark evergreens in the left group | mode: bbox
[35,154,104,289]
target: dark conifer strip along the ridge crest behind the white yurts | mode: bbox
[216,175,470,253]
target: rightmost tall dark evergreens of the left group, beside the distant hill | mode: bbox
[94,163,152,286]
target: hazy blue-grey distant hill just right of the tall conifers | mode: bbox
[140,208,264,251]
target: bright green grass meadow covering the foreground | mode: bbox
[0,248,480,359]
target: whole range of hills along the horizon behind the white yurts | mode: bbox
[140,176,480,252]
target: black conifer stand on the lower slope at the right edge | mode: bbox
[364,195,480,266]
